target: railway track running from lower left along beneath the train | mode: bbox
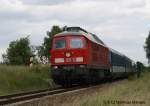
[0,80,125,106]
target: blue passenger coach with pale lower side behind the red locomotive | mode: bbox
[109,49,135,77]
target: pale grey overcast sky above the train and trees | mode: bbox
[0,0,150,64]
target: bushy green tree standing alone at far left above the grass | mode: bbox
[3,37,33,65]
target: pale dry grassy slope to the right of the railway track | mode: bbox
[65,72,150,106]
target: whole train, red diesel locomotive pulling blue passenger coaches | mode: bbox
[51,27,135,86]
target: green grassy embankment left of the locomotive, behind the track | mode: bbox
[0,65,53,95]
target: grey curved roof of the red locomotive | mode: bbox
[55,27,107,47]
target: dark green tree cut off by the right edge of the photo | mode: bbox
[144,32,150,64]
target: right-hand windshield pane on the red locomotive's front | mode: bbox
[70,38,83,48]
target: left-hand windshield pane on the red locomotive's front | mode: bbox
[53,38,66,49]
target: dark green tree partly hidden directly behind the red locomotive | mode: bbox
[41,25,62,59]
